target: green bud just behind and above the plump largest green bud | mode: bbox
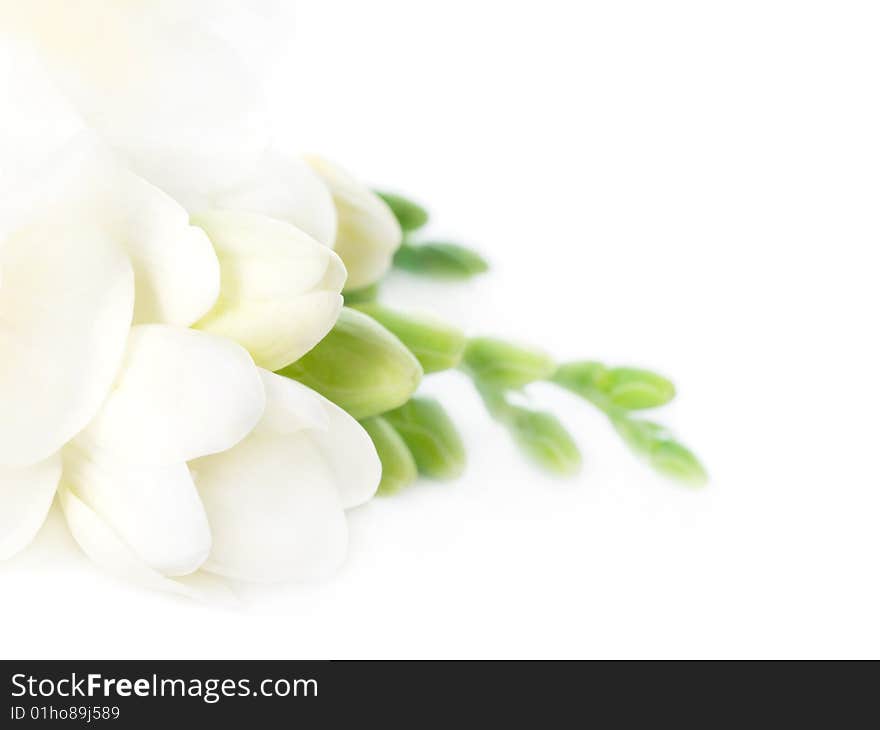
[356,303,467,373]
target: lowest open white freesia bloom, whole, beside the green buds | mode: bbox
[61,326,381,595]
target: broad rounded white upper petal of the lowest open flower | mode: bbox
[80,325,265,466]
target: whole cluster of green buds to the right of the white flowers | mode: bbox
[281,193,707,494]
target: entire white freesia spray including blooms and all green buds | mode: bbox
[0,0,705,597]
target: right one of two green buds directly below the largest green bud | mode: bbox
[384,398,466,479]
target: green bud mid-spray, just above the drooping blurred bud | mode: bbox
[463,337,556,389]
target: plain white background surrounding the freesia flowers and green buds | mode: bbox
[0,0,880,658]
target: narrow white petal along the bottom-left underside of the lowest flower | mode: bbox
[59,487,234,603]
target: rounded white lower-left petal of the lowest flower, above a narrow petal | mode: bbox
[64,441,211,576]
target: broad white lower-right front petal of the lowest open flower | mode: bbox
[190,371,368,582]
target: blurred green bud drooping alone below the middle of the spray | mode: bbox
[505,406,581,476]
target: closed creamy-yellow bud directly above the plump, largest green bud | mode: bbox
[193,211,345,370]
